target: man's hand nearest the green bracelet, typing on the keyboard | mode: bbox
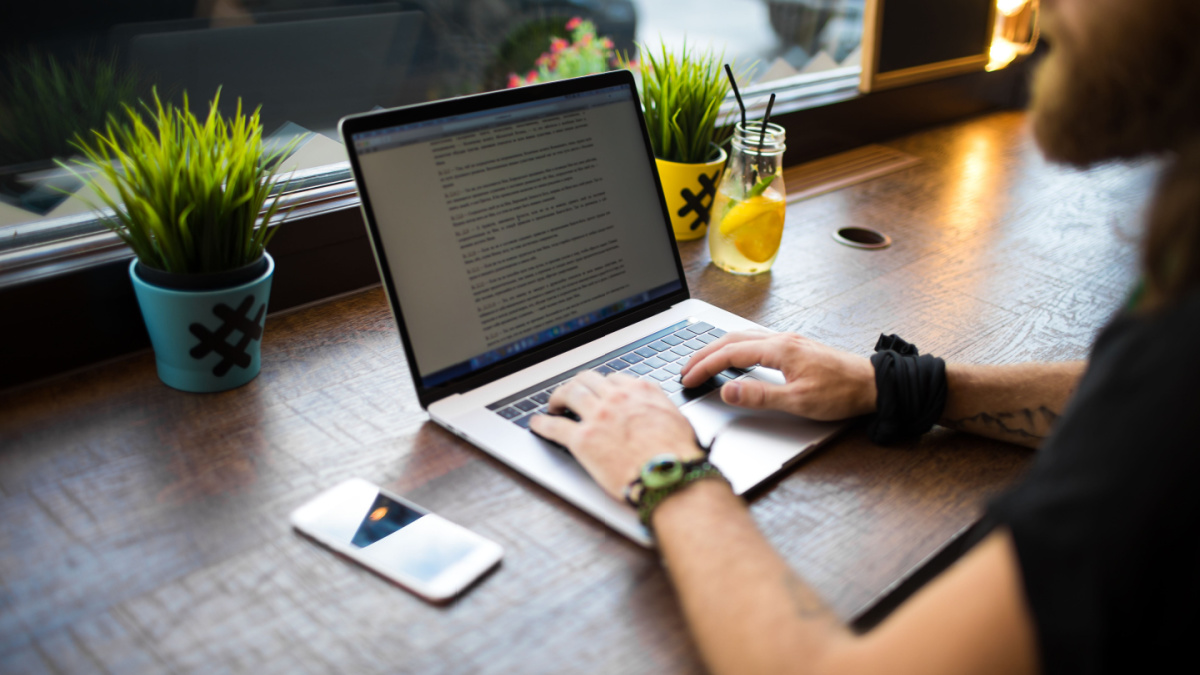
[530,370,702,500]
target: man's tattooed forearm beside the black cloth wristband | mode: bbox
[938,362,1086,448]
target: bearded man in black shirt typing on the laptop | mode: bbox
[533,0,1200,674]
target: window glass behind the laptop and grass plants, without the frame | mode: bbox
[0,0,864,259]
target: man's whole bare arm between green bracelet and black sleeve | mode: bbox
[654,480,1037,675]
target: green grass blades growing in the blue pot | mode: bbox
[59,90,301,274]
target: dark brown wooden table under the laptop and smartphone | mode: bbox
[0,113,1157,673]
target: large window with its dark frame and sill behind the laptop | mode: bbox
[0,0,1036,388]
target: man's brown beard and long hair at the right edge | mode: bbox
[1033,0,1200,309]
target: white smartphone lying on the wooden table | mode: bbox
[292,478,504,602]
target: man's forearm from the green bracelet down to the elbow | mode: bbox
[654,480,851,674]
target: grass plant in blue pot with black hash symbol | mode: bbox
[60,90,299,392]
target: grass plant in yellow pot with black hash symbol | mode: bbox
[626,44,730,240]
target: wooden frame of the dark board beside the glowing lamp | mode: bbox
[859,0,996,94]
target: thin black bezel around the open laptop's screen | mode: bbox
[338,70,690,408]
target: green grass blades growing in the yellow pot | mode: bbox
[626,42,732,163]
